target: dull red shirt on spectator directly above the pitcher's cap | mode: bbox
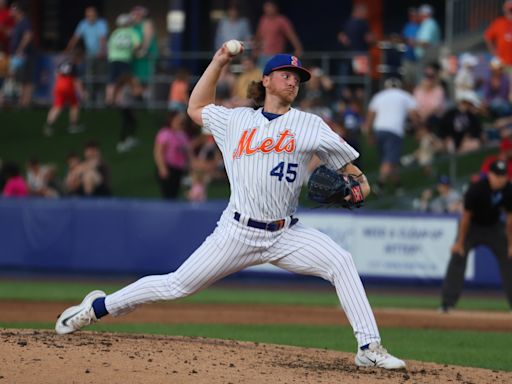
[257,15,293,55]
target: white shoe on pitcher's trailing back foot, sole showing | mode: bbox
[55,291,107,335]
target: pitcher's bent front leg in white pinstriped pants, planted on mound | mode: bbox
[272,223,380,346]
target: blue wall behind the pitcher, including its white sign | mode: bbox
[0,199,501,288]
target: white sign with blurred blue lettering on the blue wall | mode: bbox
[300,211,464,279]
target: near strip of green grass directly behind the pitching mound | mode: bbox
[0,322,512,371]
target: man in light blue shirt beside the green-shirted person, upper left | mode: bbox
[66,6,108,59]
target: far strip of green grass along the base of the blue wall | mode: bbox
[0,281,508,311]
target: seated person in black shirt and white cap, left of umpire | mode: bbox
[439,91,482,153]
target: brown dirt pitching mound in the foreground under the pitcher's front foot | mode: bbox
[0,329,512,384]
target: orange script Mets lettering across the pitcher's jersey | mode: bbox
[233,128,295,159]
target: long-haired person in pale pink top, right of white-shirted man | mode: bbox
[413,67,446,132]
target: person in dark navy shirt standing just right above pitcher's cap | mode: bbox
[338,3,374,98]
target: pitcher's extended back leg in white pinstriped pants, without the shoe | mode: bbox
[105,230,259,316]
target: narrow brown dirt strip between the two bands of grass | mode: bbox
[0,301,512,332]
